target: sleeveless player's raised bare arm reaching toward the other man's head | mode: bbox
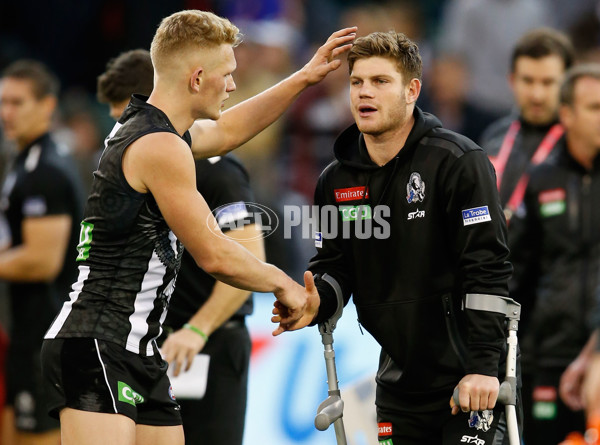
[190,27,356,158]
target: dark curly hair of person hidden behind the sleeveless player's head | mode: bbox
[97,49,154,103]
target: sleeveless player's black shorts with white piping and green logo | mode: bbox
[42,338,181,426]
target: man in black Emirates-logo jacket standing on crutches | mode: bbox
[273,31,511,445]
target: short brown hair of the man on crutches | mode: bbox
[348,31,423,83]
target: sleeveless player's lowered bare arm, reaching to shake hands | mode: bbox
[123,132,314,332]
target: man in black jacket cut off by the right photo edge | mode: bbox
[509,64,600,444]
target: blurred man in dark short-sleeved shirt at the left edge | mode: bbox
[0,60,83,444]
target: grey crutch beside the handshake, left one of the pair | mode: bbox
[315,274,347,445]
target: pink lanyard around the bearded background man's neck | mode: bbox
[491,120,565,222]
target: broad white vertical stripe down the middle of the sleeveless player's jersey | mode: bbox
[125,246,167,355]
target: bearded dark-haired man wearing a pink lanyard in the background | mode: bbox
[481,28,574,220]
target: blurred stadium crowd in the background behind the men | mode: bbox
[0,0,600,440]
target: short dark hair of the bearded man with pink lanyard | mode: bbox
[510,27,575,72]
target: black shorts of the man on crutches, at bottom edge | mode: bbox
[377,404,508,445]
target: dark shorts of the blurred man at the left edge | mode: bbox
[6,346,60,433]
